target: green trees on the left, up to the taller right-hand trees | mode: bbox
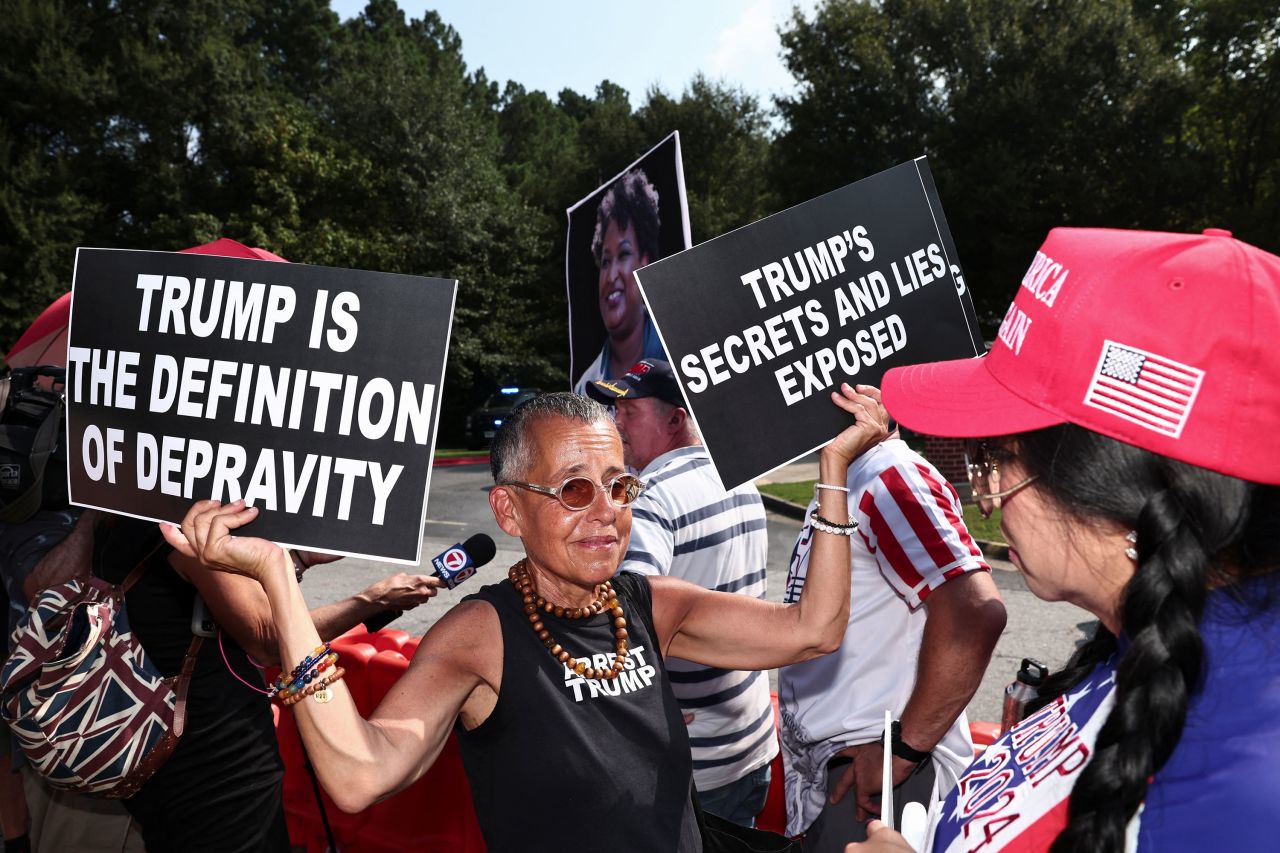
[0,0,768,437]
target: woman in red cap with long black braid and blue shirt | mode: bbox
[849,228,1280,853]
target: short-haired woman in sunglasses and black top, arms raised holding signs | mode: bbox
[164,384,887,853]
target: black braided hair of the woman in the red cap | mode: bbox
[993,425,1280,853]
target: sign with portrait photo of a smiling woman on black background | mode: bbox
[564,132,691,393]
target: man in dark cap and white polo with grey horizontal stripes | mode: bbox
[588,359,778,826]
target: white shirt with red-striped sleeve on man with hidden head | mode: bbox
[778,439,988,835]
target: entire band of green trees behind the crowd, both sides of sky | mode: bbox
[0,0,1280,409]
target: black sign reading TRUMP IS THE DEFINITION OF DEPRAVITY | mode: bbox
[67,248,457,562]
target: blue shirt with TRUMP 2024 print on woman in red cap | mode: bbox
[933,580,1280,853]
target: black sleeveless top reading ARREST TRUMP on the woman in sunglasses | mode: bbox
[456,563,701,853]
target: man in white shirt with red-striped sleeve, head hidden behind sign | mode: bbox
[778,433,1005,853]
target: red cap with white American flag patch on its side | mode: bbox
[883,228,1280,484]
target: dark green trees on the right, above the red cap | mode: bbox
[772,0,1280,326]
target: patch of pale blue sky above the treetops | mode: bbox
[332,0,814,106]
